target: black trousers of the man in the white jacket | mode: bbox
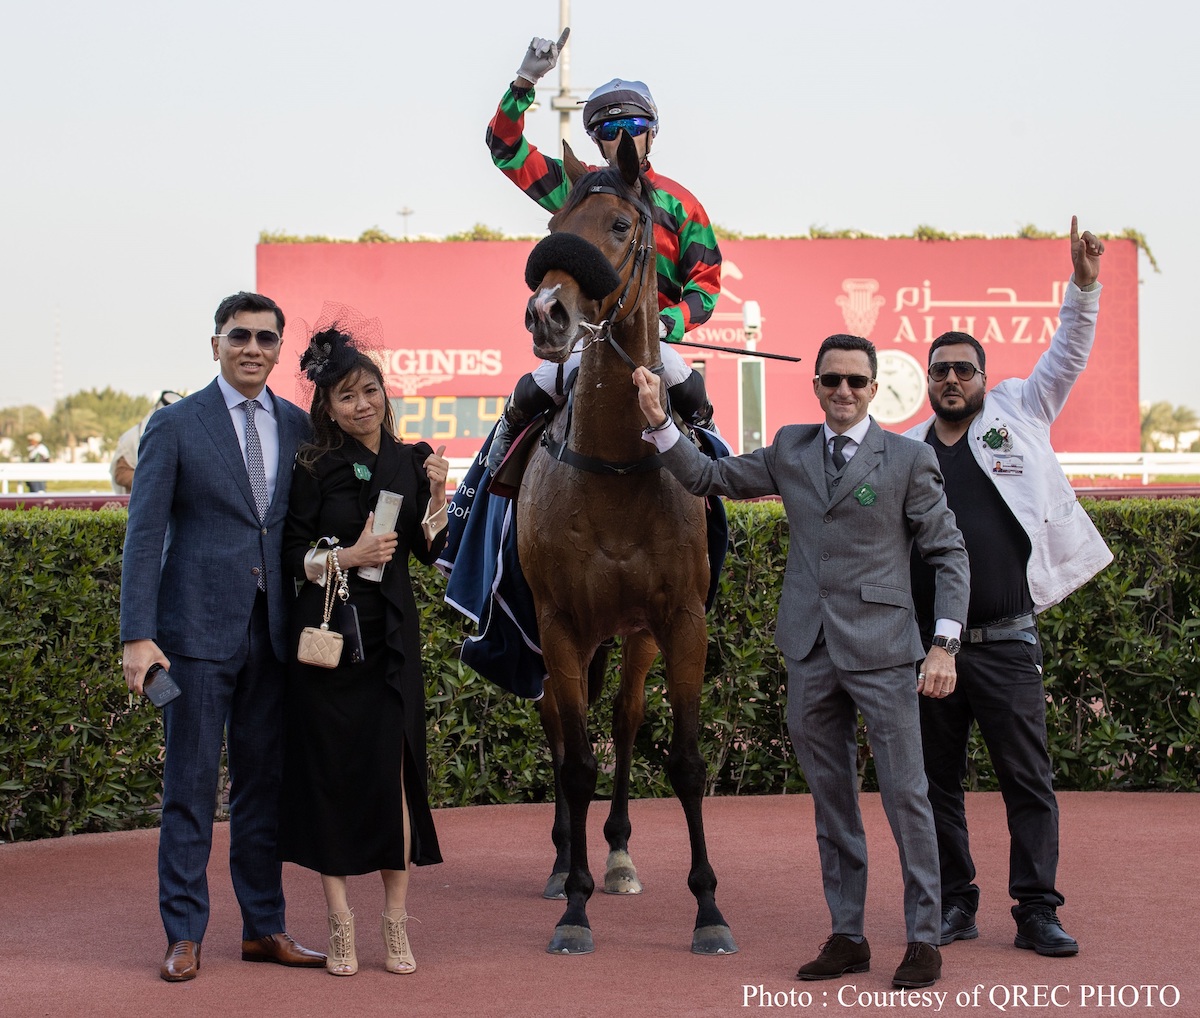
[920,630,1063,922]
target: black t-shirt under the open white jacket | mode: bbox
[912,427,1033,636]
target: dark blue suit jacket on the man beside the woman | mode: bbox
[121,381,308,661]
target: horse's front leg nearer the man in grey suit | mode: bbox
[662,609,738,954]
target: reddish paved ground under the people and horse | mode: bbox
[0,792,1200,1018]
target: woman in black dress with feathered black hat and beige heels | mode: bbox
[278,324,449,976]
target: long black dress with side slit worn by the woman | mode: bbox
[278,433,445,876]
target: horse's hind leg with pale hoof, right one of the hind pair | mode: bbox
[604,633,659,894]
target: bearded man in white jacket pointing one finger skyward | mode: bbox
[907,216,1112,956]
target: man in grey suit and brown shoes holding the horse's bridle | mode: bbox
[634,335,970,987]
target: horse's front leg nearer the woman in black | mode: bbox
[539,617,596,954]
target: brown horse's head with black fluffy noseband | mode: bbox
[526,134,658,363]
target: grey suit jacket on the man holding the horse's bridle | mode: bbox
[662,420,970,671]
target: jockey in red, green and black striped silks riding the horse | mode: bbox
[487,29,721,473]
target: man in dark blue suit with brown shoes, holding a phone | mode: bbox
[121,292,325,982]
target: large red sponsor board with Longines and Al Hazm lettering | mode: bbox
[258,239,1140,456]
